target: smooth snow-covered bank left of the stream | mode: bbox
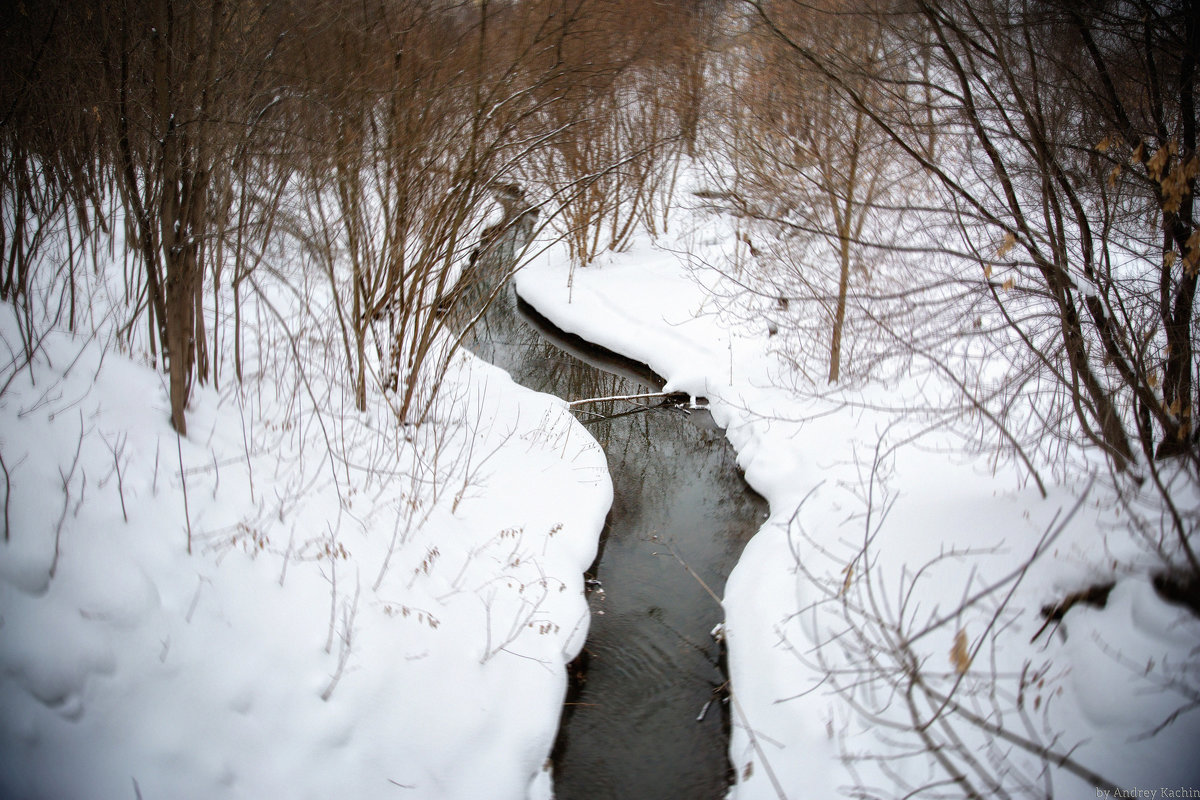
[0,267,612,800]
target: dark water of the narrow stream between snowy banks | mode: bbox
[470,284,767,800]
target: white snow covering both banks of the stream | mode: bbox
[0,165,1200,800]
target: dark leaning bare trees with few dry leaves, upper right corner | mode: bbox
[750,0,1200,515]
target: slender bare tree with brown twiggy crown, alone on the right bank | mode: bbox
[714,4,904,383]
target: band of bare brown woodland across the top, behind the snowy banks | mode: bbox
[0,0,1200,489]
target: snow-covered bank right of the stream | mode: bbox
[517,195,1200,800]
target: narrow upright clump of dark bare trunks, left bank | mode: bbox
[97,0,250,434]
